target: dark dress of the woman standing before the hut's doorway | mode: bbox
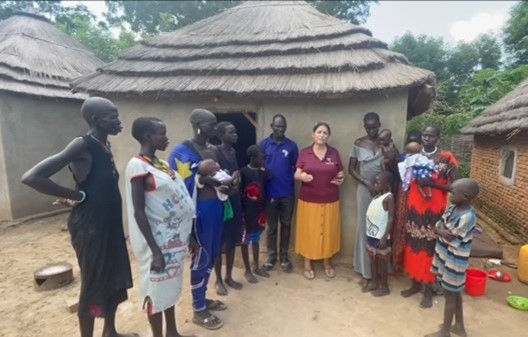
[218,147,244,253]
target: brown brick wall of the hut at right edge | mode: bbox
[471,132,528,243]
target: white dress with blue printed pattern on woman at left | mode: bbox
[126,157,195,315]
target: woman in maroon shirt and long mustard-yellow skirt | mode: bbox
[295,123,345,280]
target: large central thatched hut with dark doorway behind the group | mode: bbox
[72,1,435,256]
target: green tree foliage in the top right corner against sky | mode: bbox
[504,1,528,66]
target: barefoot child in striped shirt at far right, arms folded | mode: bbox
[426,178,479,337]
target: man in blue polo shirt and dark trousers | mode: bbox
[259,115,299,273]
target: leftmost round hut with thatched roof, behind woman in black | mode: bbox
[0,13,103,219]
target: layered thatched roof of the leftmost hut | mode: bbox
[0,13,104,99]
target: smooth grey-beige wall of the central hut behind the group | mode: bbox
[108,89,408,262]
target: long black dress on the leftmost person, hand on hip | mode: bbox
[68,136,132,317]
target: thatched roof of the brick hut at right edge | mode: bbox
[462,79,528,134]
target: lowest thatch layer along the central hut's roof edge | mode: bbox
[71,63,435,96]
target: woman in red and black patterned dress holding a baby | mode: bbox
[401,126,459,308]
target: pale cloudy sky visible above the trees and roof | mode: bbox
[71,1,516,44]
